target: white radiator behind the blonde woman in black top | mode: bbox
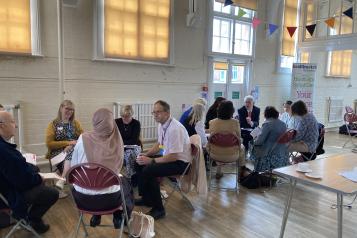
[113,102,157,143]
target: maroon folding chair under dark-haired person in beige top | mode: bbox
[208,132,241,192]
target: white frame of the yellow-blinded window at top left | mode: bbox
[0,0,43,57]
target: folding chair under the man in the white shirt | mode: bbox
[165,143,200,211]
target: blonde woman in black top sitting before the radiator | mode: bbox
[115,105,142,187]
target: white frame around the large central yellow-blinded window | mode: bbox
[92,0,175,67]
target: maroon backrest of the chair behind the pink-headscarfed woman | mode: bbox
[67,163,121,190]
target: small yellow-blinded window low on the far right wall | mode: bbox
[327,50,352,78]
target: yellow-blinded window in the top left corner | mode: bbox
[0,0,40,55]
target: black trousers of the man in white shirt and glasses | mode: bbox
[136,160,188,210]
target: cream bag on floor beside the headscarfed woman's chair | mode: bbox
[129,211,155,238]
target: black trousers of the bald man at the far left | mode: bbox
[24,184,58,223]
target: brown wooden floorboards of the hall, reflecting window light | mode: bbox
[0,132,357,238]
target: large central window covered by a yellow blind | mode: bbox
[101,0,171,63]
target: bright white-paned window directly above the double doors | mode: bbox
[211,1,255,56]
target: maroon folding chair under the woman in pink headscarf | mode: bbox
[67,163,130,237]
